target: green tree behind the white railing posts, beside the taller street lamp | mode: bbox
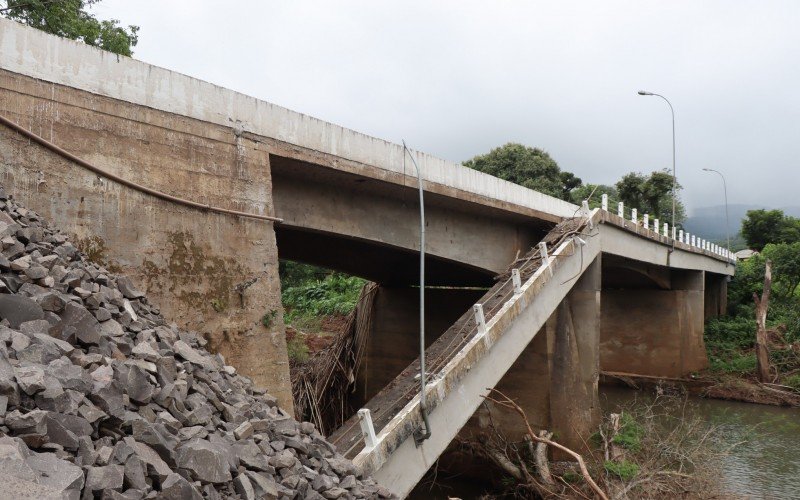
[615,169,686,224]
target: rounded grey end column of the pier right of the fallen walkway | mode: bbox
[550,256,601,451]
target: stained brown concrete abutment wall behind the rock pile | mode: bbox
[0,68,291,407]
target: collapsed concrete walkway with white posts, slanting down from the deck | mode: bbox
[330,208,601,496]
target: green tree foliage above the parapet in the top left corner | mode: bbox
[0,0,139,56]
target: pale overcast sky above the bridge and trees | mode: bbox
[94,0,800,211]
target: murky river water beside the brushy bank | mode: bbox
[601,387,800,499]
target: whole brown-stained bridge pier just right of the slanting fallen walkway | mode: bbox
[465,255,601,450]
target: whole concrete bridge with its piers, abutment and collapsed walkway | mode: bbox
[0,19,733,495]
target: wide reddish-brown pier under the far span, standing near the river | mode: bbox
[600,270,708,377]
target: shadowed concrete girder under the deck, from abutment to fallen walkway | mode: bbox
[270,155,549,282]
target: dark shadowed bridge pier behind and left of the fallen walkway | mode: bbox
[351,286,484,407]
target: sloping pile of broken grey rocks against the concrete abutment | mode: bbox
[0,188,389,500]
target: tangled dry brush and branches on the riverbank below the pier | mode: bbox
[454,391,728,499]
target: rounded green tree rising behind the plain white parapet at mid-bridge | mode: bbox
[464,143,582,201]
